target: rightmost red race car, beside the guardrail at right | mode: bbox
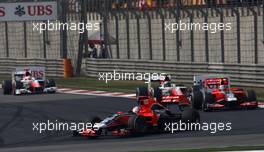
[192,76,258,111]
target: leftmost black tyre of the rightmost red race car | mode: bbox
[191,89,203,110]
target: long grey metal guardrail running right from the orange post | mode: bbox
[85,59,264,87]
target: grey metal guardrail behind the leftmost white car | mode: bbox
[0,58,63,77]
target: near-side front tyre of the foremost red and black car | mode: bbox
[128,115,148,134]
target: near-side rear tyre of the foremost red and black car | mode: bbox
[181,108,200,131]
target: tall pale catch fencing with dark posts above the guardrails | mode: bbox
[0,0,264,81]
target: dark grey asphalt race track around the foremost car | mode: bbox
[0,90,264,152]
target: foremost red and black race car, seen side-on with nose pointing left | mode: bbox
[73,97,200,138]
